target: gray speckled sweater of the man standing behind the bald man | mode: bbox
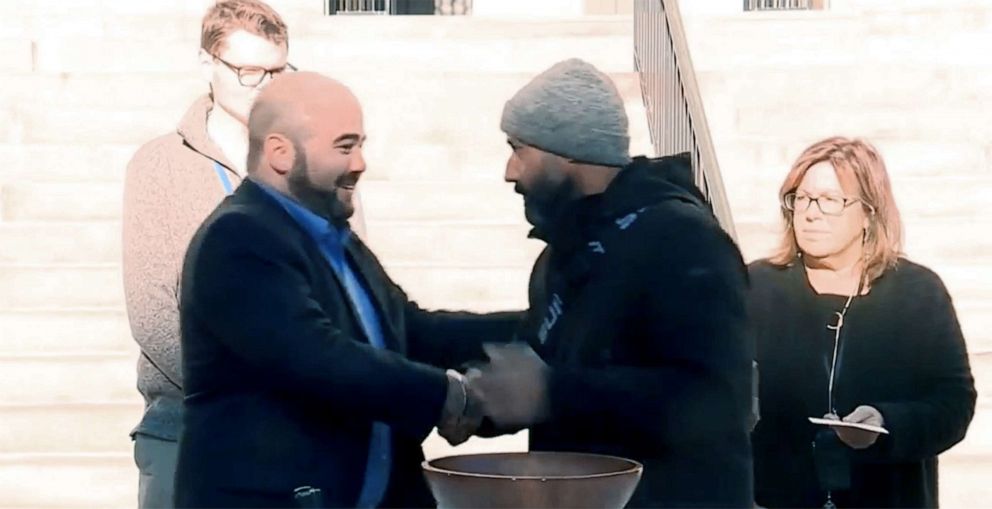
[123,96,241,440]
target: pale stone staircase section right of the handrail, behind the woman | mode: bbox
[686,0,992,507]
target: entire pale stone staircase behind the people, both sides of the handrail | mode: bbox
[0,0,992,508]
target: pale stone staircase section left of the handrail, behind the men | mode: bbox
[0,0,650,508]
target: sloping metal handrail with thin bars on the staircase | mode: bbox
[634,0,737,240]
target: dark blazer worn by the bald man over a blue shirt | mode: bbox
[176,180,519,507]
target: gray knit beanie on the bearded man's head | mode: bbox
[500,58,630,166]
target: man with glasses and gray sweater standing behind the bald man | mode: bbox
[123,0,363,508]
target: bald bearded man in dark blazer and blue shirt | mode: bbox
[176,72,520,507]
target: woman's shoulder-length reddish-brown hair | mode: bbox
[769,136,902,283]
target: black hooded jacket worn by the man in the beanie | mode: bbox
[524,157,753,507]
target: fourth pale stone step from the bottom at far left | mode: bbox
[0,308,134,357]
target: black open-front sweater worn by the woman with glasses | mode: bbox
[749,259,976,507]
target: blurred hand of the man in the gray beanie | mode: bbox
[467,343,549,433]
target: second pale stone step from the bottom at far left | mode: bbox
[0,402,144,454]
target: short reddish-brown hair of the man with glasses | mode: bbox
[200,0,289,55]
